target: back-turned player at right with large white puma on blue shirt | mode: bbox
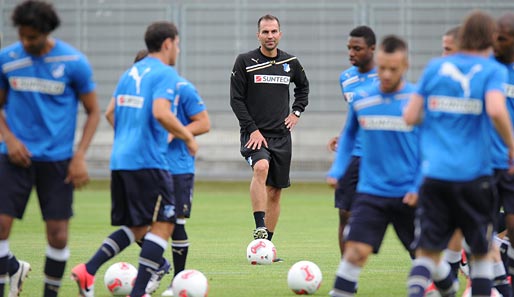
[404,11,514,297]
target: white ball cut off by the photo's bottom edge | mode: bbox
[171,269,209,297]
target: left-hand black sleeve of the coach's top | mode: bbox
[230,55,258,133]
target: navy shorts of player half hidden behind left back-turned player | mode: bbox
[171,173,195,218]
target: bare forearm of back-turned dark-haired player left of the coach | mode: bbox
[152,98,198,156]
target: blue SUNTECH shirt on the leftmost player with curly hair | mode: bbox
[0,39,96,161]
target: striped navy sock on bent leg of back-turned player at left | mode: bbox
[86,226,134,275]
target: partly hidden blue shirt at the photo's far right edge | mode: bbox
[493,63,514,169]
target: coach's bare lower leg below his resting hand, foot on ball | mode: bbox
[250,159,269,213]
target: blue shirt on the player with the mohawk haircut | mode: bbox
[328,82,421,198]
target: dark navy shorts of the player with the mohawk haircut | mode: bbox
[344,193,415,253]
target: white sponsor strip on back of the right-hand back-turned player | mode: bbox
[428,96,483,115]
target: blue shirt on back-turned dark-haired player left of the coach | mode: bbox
[111,57,179,170]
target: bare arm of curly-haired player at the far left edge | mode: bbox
[0,90,32,167]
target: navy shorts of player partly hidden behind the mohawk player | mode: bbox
[334,156,361,211]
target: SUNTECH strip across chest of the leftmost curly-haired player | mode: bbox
[9,76,66,95]
